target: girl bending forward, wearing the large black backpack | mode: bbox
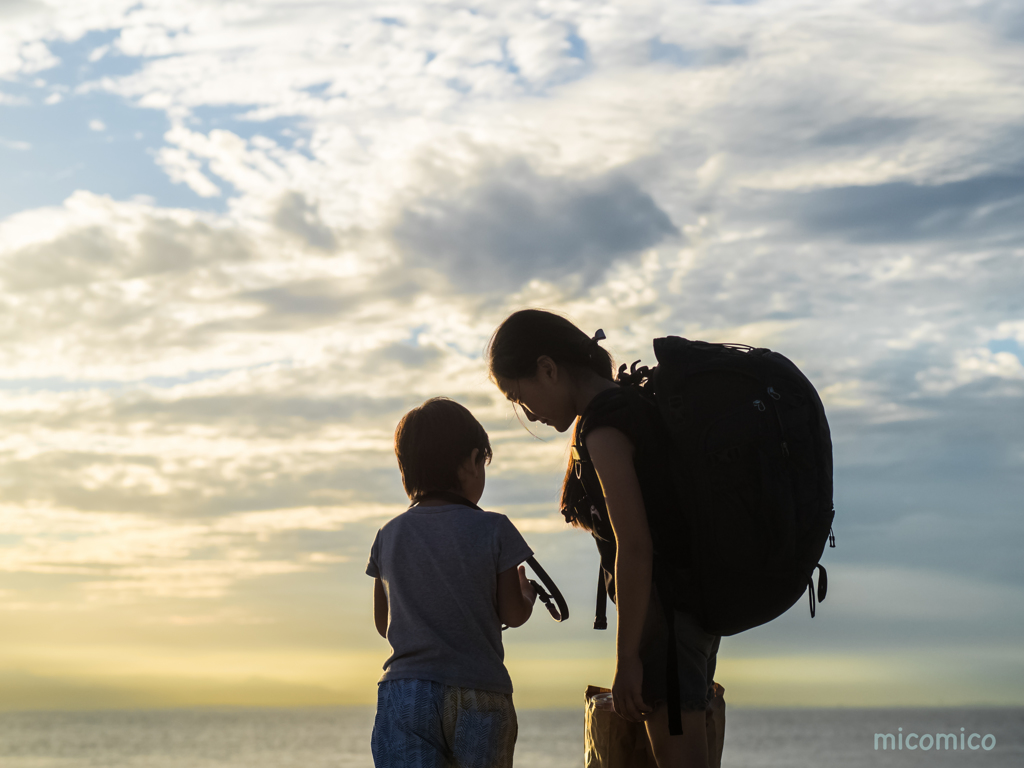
[488,309,721,768]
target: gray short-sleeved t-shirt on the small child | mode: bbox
[367,504,534,693]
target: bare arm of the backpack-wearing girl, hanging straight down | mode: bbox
[587,427,653,721]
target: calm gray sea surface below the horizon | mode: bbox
[0,707,1024,768]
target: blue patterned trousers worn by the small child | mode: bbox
[370,680,519,768]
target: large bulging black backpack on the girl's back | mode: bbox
[573,336,835,737]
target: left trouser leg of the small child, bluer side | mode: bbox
[370,680,452,768]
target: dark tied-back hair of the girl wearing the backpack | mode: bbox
[487,309,615,529]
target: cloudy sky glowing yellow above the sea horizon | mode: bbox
[0,0,1024,710]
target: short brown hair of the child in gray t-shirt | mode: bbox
[394,397,492,502]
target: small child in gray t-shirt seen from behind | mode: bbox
[367,397,537,768]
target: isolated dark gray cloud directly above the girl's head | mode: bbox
[392,164,679,291]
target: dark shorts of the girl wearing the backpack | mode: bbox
[640,589,722,712]
